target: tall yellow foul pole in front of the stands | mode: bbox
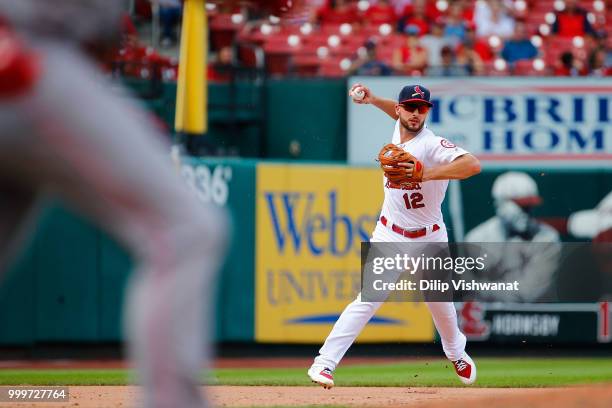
[174,0,208,135]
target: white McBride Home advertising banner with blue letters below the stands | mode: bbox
[347,77,612,167]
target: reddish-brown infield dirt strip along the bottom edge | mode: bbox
[0,384,612,408]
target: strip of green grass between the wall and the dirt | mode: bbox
[0,358,612,387]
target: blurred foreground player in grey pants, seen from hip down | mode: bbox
[0,0,227,408]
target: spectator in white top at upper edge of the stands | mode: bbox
[474,0,514,38]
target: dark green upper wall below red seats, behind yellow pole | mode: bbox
[126,79,347,161]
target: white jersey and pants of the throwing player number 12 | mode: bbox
[315,121,468,370]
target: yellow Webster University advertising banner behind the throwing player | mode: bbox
[255,163,434,343]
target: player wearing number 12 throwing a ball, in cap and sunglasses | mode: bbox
[308,84,480,389]
